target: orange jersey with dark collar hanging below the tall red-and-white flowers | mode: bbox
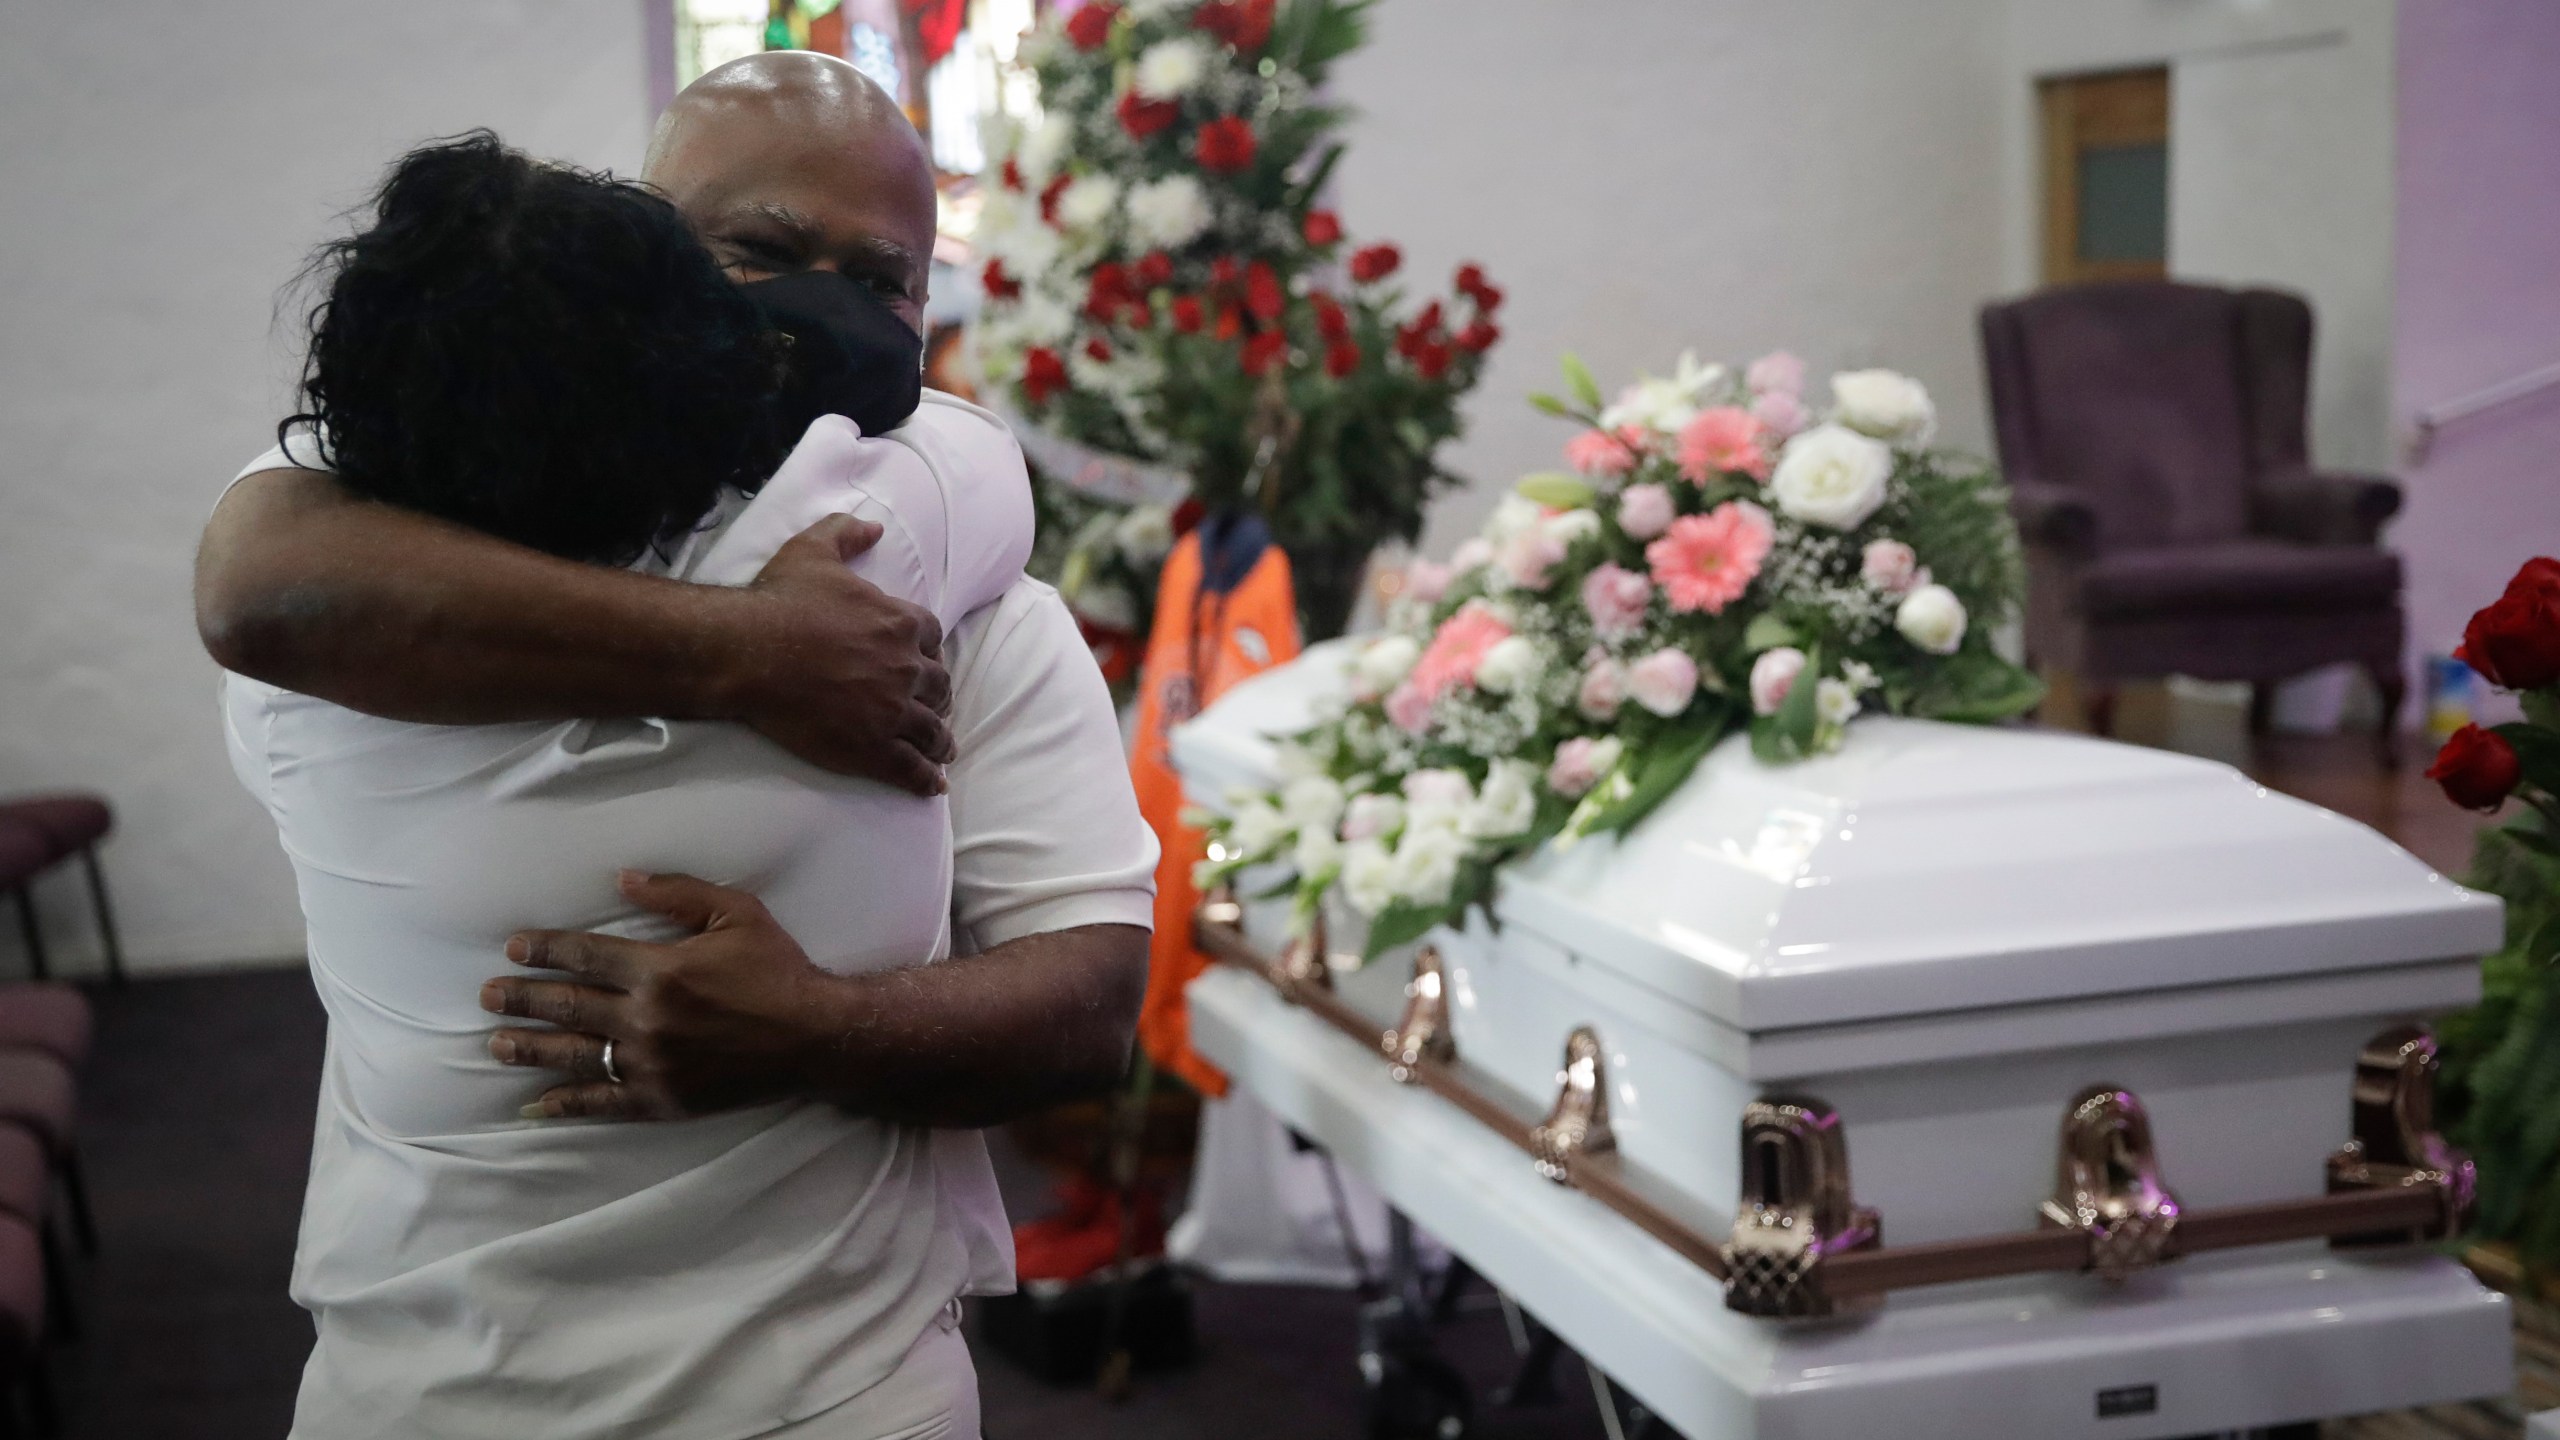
[1129,515,1298,1094]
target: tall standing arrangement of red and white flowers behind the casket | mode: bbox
[975,0,1503,633]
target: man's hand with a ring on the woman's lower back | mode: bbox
[481,871,840,1120]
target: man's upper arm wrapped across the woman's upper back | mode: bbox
[195,469,952,794]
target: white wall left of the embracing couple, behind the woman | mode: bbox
[0,0,650,974]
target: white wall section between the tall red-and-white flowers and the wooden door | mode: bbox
[1334,0,2012,553]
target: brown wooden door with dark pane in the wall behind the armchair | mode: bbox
[2038,67,2168,284]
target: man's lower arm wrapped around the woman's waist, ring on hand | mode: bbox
[481,876,1147,1127]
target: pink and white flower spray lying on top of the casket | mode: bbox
[1198,354,2040,956]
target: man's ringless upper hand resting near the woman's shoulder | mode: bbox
[735,515,952,794]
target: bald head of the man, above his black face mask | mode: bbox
[643,51,934,331]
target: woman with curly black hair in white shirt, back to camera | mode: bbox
[225,133,1032,1440]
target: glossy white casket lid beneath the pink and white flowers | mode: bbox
[1175,646,2501,1033]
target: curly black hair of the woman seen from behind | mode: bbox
[279,131,786,564]
